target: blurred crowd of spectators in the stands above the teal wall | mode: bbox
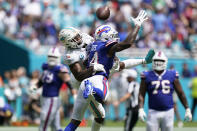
[0,0,197,55]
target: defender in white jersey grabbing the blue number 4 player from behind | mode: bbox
[59,9,154,130]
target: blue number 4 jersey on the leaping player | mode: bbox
[88,41,116,78]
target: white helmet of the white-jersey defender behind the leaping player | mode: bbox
[59,27,83,48]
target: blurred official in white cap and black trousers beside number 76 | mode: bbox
[113,69,140,131]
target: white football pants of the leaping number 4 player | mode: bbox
[72,75,109,121]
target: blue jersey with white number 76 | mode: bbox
[141,70,179,111]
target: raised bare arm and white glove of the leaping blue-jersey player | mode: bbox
[108,10,148,56]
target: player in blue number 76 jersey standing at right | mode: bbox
[139,51,192,131]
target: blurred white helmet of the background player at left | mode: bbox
[47,47,61,66]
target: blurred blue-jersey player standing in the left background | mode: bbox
[31,47,76,131]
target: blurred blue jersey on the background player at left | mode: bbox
[42,64,67,97]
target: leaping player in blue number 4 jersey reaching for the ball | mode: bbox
[65,11,149,131]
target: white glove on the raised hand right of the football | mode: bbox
[131,10,148,26]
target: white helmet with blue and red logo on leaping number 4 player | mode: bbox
[94,25,120,42]
